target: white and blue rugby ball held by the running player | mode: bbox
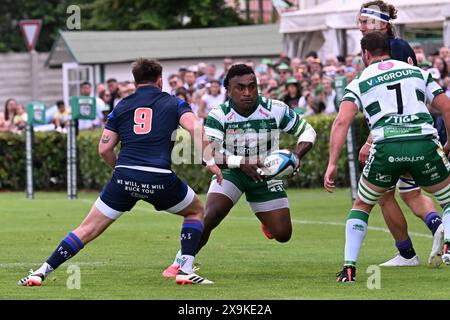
[259,149,298,180]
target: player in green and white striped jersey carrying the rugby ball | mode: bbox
[163,64,316,277]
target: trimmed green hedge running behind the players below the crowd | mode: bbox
[0,116,368,192]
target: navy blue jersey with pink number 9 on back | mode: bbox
[105,86,192,170]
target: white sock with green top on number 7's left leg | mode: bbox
[344,210,369,265]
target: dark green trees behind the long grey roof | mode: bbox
[0,0,248,52]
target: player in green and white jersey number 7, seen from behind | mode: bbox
[324,32,450,282]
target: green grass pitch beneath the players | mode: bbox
[0,189,450,300]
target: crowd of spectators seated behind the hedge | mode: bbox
[0,45,450,144]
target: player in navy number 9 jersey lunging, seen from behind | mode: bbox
[19,58,222,286]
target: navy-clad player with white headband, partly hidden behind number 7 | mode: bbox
[358,0,444,267]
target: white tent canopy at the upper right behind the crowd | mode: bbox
[280,0,450,58]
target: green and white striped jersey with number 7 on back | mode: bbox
[342,59,444,142]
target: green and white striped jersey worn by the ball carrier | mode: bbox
[205,96,309,157]
